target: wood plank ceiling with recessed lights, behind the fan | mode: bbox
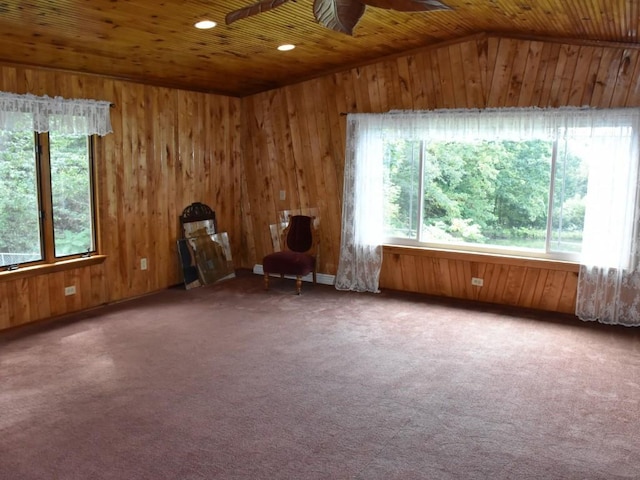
[0,0,640,97]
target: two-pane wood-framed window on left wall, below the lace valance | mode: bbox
[0,128,96,270]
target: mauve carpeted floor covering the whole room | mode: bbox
[0,273,640,480]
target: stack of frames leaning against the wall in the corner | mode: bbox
[178,202,235,290]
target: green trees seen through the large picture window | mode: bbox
[384,139,588,254]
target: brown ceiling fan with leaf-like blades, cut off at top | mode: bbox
[226,0,452,35]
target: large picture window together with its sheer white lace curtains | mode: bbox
[336,108,640,325]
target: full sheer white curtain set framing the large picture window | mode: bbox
[336,108,640,325]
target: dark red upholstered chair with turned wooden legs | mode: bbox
[262,215,319,295]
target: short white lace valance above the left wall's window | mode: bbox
[0,92,113,136]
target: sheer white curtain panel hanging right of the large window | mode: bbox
[576,115,640,326]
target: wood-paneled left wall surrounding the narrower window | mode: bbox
[0,67,246,329]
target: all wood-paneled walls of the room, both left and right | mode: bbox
[0,35,640,329]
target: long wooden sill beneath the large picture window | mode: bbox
[383,245,580,273]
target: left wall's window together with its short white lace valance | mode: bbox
[0,92,111,269]
